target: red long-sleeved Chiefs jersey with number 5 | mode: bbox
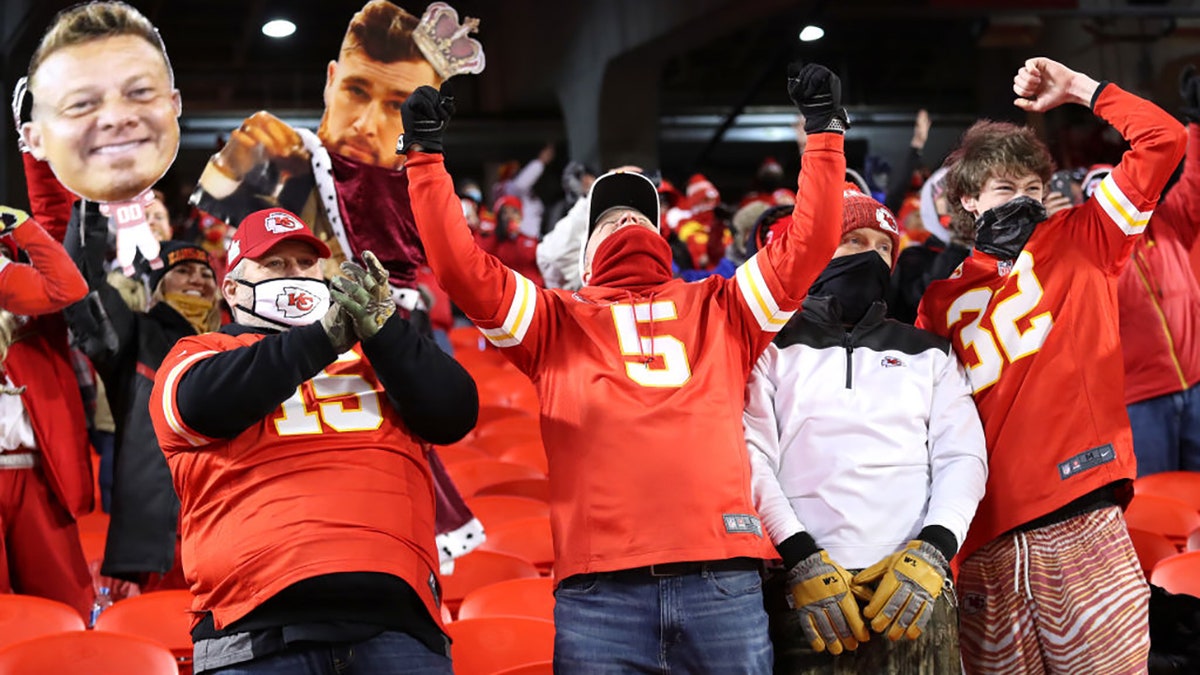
[407,133,845,579]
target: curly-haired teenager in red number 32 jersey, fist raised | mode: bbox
[918,58,1184,675]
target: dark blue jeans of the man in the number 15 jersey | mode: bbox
[205,631,454,675]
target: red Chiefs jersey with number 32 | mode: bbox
[917,84,1184,558]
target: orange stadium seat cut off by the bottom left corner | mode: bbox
[0,631,179,675]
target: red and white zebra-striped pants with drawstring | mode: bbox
[958,507,1150,675]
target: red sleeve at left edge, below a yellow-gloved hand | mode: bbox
[0,219,88,316]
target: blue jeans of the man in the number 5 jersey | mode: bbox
[554,571,772,675]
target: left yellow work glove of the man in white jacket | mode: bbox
[787,550,871,655]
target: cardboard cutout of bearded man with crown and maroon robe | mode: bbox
[192,0,485,565]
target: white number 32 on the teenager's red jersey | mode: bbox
[946,251,1054,394]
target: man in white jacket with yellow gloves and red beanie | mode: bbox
[744,185,988,674]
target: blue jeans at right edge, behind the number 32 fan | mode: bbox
[1128,386,1200,476]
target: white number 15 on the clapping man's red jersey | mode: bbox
[275,351,383,436]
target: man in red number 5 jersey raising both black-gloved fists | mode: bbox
[400,65,846,673]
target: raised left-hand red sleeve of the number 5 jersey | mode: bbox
[404,153,547,371]
